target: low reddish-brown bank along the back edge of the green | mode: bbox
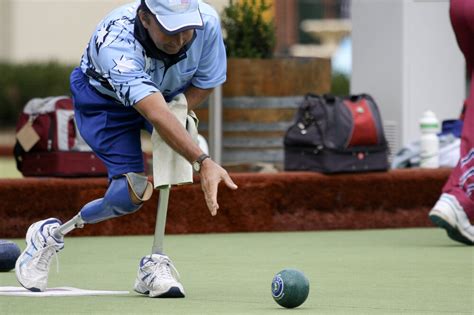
[0,169,450,238]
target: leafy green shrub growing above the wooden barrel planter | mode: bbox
[222,0,276,58]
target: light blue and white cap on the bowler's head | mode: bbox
[145,0,204,34]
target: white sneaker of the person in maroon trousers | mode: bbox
[429,193,474,245]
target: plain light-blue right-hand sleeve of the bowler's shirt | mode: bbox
[191,19,227,89]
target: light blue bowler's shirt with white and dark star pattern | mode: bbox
[81,0,227,106]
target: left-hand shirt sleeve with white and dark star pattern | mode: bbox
[90,23,159,106]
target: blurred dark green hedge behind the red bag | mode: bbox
[0,62,74,127]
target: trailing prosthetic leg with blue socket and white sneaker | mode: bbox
[15,173,153,292]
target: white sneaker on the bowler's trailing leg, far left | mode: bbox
[15,218,64,292]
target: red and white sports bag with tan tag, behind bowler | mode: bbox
[14,96,107,177]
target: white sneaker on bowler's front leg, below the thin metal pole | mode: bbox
[134,254,184,298]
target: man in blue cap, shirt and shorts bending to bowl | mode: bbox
[15,0,237,297]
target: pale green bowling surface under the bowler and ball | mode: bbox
[0,228,474,315]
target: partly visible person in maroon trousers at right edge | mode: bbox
[429,0,474,245]
